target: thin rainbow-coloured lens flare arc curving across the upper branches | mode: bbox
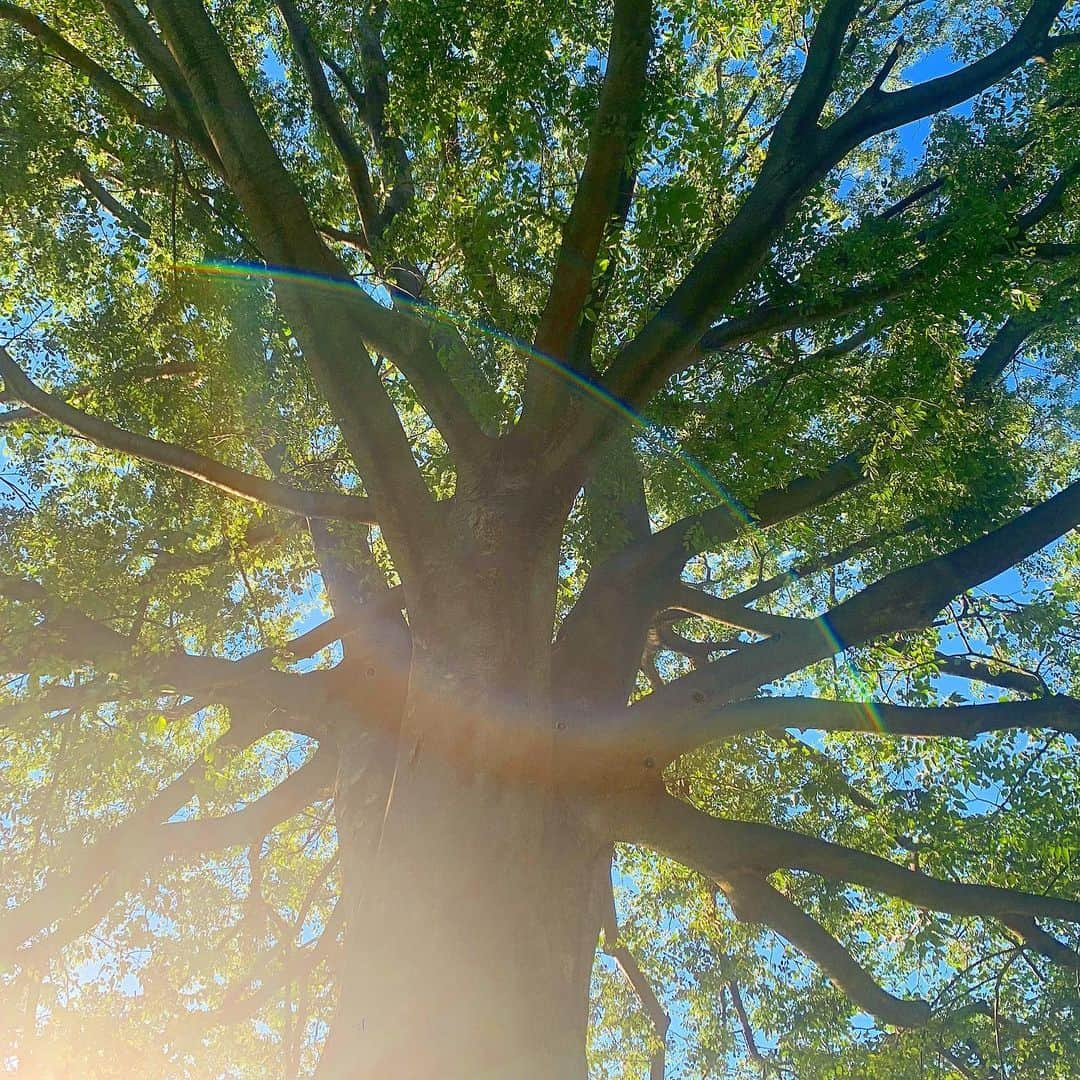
[177,260,887,732]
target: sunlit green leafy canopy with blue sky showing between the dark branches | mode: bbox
[0,0,1080,1080]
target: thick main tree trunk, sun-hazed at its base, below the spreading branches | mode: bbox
[322,509,609,1080]
